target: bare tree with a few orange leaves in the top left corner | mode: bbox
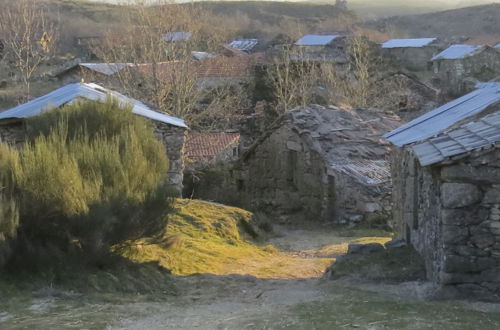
[0,0,57,98]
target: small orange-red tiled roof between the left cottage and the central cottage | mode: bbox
[185,132,240,161]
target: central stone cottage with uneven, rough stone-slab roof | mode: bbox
[230,105,401,223]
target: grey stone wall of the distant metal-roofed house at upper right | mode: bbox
[433,48,500,96]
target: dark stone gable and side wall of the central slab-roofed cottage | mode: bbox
[232,125,390,224]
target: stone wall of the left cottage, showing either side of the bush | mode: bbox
[0,120,186,196]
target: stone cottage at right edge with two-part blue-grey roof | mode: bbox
[385,83,500,299]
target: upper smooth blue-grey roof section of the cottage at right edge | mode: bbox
[384,84,500,147]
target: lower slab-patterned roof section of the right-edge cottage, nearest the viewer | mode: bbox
[413,111,500,166]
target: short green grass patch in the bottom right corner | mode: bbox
[258,286,500,330]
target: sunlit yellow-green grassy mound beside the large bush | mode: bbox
[117,199,333,278]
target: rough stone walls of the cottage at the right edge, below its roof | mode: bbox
[393,150,500,299]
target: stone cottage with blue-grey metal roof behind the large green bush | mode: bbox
[0,83,187,195]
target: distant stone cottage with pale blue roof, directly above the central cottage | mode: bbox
[292,34,348,64]
